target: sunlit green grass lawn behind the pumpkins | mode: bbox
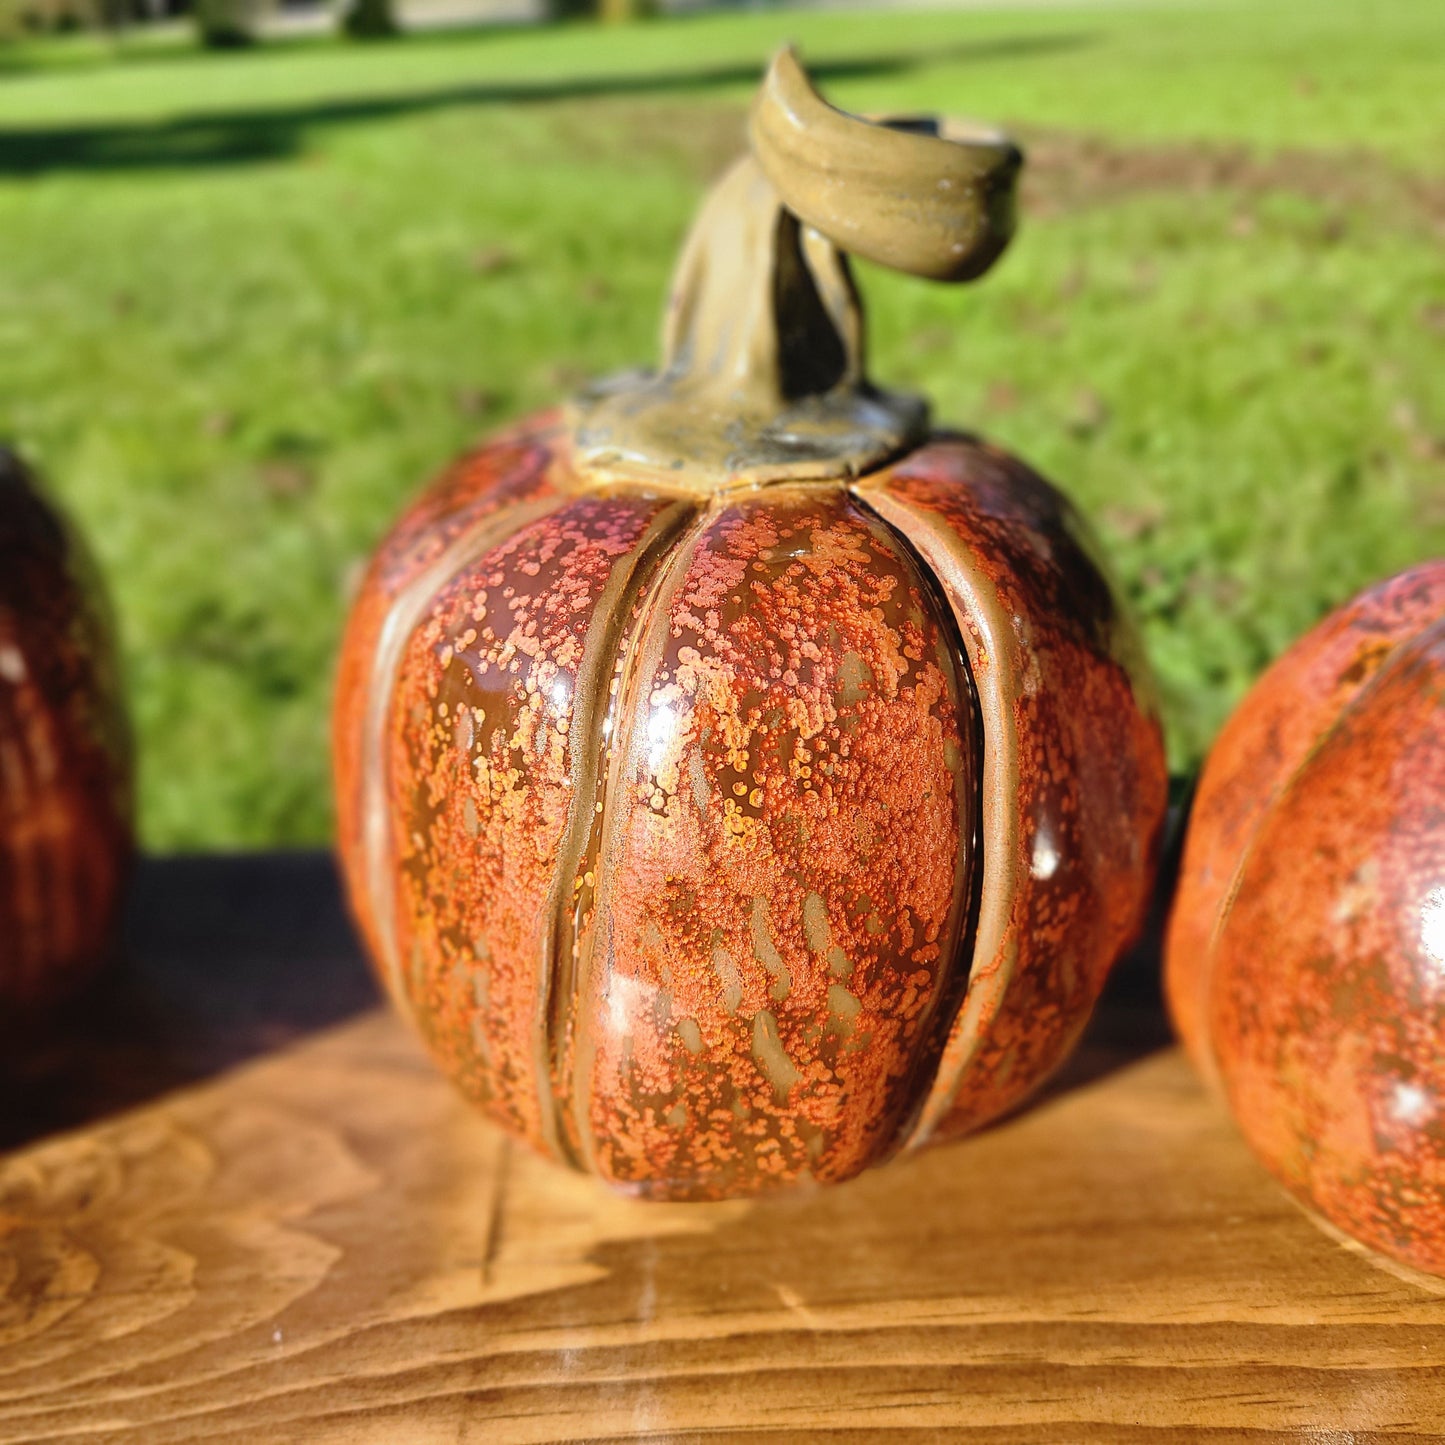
[0,0,1445,848]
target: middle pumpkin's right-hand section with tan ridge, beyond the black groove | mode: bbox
[864,439,1169,1137]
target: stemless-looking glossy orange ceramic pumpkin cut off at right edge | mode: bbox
[1166,561,1445,1274]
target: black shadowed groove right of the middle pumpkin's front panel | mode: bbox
[850,487,988,1163]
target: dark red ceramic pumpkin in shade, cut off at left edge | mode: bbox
[0,449,130,1022]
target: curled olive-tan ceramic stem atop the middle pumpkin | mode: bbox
[572,51,1023,493]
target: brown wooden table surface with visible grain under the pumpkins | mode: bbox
[0,855,1445,1445]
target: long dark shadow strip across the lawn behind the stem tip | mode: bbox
[0,35,1092,176]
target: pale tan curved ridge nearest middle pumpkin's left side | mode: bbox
[360,496,568,1034]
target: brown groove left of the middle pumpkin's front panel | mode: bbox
[536,501,698,1168]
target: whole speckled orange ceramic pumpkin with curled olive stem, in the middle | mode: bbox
[335,53,1166,1198]
